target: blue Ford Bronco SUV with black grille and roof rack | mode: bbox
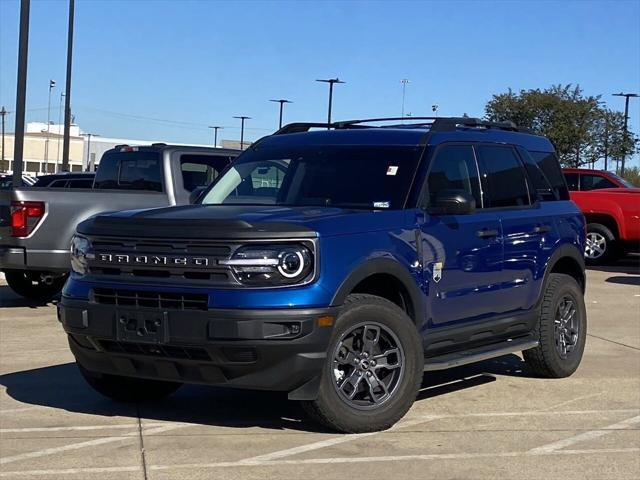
[59,118,586,432]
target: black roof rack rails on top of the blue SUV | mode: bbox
[274,117,531,135]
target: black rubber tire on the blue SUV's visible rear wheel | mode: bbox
[523,273,587,378]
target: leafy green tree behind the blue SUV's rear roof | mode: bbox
[485,85,634,167]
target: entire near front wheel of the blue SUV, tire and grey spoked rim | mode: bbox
[303,294,424,433]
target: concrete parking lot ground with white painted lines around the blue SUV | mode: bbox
[0,257,640,480]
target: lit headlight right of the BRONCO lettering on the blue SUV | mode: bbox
[219,244,313,287]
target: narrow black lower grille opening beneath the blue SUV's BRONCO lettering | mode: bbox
[93,288,209,310]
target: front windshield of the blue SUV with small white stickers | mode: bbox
[202,145,420,209]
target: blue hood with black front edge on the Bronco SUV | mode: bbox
[78,205,405,239]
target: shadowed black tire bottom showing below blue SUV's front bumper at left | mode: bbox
[78,364,182,402]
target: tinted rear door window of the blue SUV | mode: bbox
[475,145,530,208]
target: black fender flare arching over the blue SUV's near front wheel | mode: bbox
[331,258,425,330]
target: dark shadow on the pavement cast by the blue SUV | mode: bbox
[0,355,527,432]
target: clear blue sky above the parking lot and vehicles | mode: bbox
[0,0,640,161]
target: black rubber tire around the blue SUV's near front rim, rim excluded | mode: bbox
[302,294,424,433]
